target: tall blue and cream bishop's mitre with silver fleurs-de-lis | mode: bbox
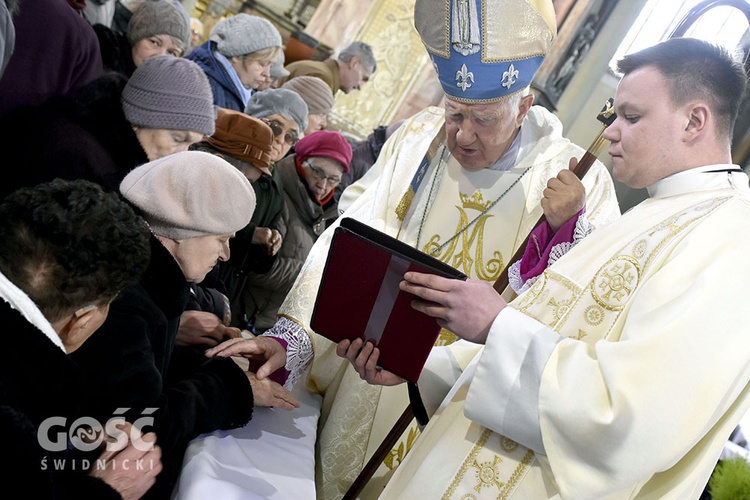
[414,0,557,103]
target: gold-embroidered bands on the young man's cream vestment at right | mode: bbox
[443,199,725,500]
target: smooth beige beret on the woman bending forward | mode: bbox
[120,151,255,240]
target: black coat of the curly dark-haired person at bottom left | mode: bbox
[0,299,121,499]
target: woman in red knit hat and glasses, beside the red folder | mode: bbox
[245,130,352,333]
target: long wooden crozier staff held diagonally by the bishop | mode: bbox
[342,97,617,500]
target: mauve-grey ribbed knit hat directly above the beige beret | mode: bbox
[122,56,216,135]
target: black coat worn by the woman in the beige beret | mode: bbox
[72,237,253,498]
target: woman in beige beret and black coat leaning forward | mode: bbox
[74,151,298,498]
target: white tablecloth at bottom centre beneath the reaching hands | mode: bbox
[173,384,321,500]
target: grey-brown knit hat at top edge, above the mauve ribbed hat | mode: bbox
[127,0,190,50]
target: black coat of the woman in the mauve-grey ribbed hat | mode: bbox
[0,73,148,198]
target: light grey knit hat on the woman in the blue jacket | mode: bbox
[209,13,281,57]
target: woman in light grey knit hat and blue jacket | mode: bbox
[187,13,281,111]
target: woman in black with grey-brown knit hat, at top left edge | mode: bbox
[94,0,190,76]
